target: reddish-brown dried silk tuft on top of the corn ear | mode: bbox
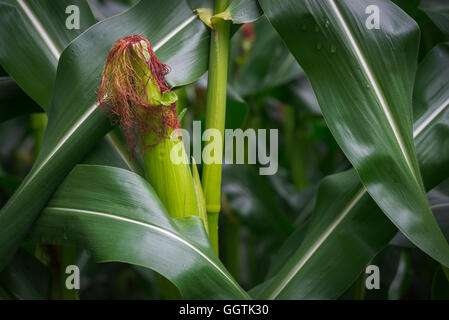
[97,35,180,157]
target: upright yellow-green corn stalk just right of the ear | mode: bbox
[202,0,230,255]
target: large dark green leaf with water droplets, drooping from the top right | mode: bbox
[260,0,449,265]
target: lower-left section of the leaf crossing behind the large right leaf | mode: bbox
[252,170,396,299]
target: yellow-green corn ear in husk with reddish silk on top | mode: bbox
[98,35,200,218]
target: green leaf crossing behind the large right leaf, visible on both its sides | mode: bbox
[250,37,449,299]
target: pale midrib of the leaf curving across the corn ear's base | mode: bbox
[45,207,246,297]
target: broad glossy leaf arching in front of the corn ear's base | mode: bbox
[25,165,249,299]
